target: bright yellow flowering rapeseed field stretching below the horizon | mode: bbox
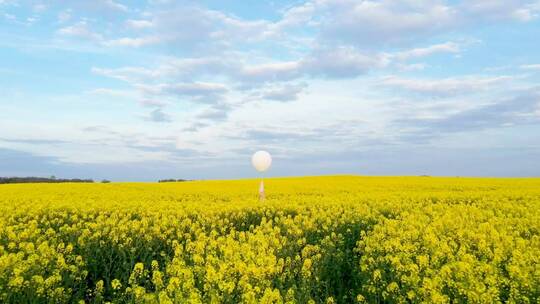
[0,176,540,303]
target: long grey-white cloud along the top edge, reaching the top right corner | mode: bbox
[277,0,540,49]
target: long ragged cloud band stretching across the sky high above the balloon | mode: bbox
[92,47,391,88]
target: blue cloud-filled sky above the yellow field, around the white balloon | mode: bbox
[0,0,540,181]
